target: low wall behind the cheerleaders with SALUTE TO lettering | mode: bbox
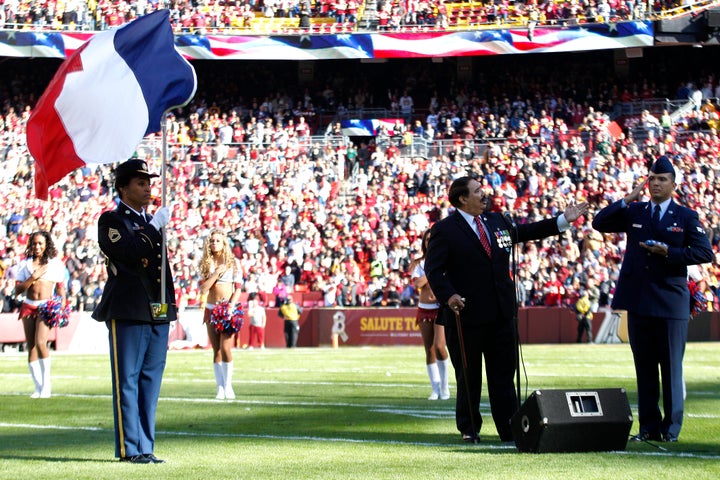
[0,307,720,353]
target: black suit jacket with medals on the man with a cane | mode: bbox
[425,212,560,325]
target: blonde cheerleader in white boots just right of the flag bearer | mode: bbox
[198,229,243,400]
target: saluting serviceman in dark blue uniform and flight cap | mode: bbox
[593,156,713,442]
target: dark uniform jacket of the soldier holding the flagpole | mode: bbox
[92,203,177,323]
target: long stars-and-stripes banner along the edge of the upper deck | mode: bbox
[0,0,720,61]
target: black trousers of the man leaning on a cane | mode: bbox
[445,314,518,442]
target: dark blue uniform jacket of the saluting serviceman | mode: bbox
[593,200,713,320]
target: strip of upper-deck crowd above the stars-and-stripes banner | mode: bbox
[0,0,682,34]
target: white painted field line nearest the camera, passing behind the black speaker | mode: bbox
[0,422,720,460]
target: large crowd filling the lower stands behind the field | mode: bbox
[0,55,720,318]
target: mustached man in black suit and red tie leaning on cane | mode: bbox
[425,177,587,442]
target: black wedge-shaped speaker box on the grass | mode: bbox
[510,388,633,453]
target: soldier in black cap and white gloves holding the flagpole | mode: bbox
[93,159,177,463]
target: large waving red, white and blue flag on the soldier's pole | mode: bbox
[27,10,197,200]
